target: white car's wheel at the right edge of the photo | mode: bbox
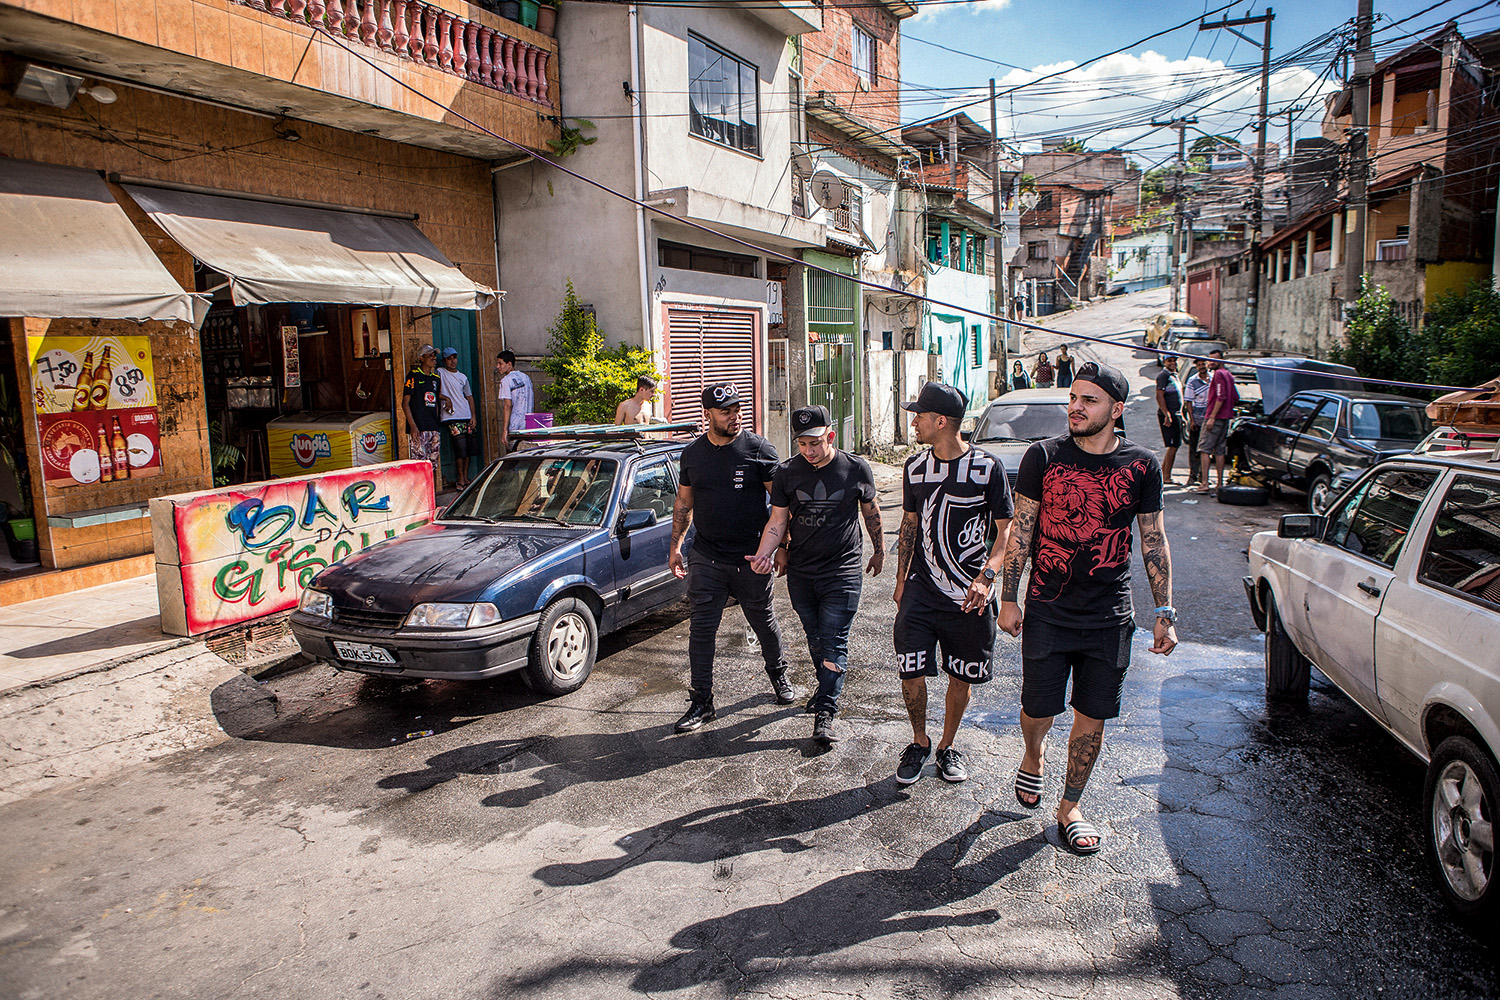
[1422,736,1500,916]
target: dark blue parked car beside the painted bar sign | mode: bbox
[291,436,692,694]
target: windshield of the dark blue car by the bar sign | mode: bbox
[443,456,615,526]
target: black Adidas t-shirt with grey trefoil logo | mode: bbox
[771,451,875,576]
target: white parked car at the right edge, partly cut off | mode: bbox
[1245,448,1500,918]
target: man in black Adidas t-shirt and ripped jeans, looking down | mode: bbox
[746,406,885,744]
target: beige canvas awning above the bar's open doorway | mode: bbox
[125,184,495,309]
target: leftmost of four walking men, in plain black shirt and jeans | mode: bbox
[668,382,797,733]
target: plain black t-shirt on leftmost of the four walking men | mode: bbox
[681,430,779,562]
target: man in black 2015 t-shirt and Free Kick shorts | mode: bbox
[894,382,1013,784]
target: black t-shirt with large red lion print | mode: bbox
[1016,435,1161,628]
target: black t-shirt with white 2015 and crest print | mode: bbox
[902,448,1016,610]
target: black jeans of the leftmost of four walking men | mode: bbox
[687,552,786,702]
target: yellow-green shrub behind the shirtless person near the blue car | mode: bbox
[537,279,662,424]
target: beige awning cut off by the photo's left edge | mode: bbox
[0,159,209,322]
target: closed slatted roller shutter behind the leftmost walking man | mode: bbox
[666,307,761,433]
